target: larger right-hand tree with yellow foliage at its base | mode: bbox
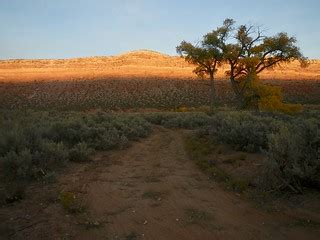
[224,22,307,111]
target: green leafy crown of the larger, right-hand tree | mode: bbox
[223,21,307,83]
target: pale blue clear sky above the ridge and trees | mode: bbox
[0,0,320,59]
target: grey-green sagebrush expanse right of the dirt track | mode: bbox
[202,112,320,192]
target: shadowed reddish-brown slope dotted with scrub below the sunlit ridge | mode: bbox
[0,79,320,110]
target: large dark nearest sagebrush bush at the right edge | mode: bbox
[265,119,320,193]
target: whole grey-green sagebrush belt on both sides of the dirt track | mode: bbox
[0,110,320,199]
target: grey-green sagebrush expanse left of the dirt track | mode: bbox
[0,111,150,184]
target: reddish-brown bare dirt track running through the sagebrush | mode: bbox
[0,127,320,240]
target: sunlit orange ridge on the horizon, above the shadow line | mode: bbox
[0,50,320,82]
